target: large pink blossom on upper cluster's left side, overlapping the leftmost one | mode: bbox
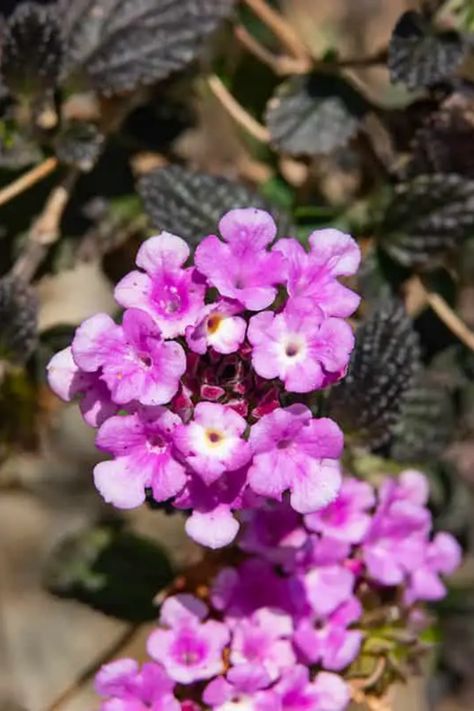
[72,309,186,405]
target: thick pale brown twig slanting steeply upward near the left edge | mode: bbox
[12,169,78,281]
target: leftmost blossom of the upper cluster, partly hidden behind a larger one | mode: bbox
[47,347,118,427]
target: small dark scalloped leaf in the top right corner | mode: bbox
[388,10,464,89]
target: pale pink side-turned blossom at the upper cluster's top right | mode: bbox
[274,229,360,318]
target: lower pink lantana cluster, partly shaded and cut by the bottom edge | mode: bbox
[96,470,461,711]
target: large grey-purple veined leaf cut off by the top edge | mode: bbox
[59,0,234,93]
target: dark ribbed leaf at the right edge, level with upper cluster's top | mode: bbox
[380,174,474,269]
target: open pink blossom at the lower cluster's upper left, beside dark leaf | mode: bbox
[148,594,229,684]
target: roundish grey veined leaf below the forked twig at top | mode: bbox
[265,73,369,156]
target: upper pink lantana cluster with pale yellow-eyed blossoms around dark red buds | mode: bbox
[48,209,360,548]
